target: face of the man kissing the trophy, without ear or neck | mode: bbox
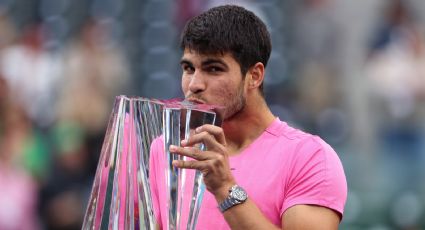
[180,50,246,119]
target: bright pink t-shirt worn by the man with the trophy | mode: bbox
[149,118,347,230]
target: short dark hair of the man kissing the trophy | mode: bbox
[180,5,271,90]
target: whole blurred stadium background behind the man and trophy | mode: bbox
[0,0,425,230]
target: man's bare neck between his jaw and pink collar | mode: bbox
[222,97,275,155]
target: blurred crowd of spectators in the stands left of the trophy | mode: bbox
[0,9,129,230]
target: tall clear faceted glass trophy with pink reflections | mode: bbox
[82,96,216,230]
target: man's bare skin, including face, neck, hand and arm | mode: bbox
[165,49,340,229]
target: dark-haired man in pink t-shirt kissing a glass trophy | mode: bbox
[150,6,347,230]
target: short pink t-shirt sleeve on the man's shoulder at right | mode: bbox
[281,136,347,217]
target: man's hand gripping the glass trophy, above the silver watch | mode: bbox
[170,125,235,196]
